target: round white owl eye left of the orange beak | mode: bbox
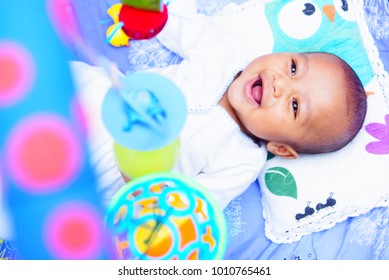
[278,0,322,40]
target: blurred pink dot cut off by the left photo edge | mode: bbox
[0,42,35,107]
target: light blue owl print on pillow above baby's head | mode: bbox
[265,0,374,86]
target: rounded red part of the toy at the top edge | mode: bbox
[119,5,168,40]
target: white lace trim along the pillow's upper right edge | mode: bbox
[349,0,389,108]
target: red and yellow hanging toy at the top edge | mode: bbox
[106,0,168,47]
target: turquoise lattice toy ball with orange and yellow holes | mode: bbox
[106,173,226,260]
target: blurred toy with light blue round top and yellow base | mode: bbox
[102,73,186,179]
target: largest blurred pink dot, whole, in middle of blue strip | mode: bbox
[6,114,82,193]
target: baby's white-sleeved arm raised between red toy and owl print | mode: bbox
[157,0,274,62]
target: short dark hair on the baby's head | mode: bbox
[294,53,367,154]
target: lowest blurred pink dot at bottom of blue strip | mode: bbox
[43,202,104,259]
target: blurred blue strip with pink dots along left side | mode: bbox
[0,0,108,260]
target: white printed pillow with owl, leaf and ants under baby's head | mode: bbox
[253,0,389,243]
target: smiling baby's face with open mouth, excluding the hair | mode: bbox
[227,53,346,149]
